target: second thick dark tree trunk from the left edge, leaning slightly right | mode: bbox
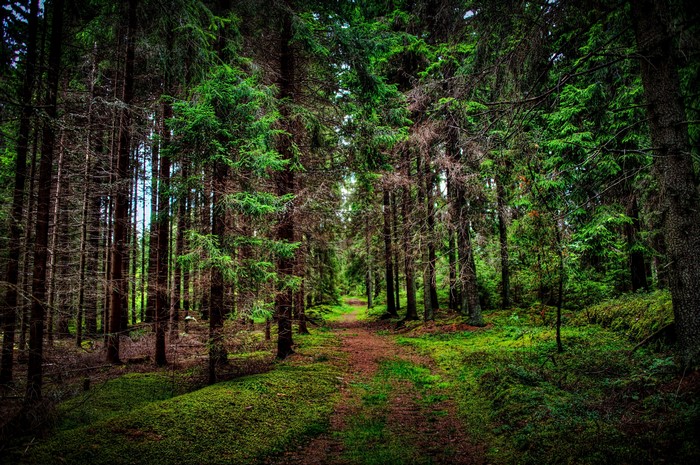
[25,0,64,405]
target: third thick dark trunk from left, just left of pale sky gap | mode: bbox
[107,0,137,363]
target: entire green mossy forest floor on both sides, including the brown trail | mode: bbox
[3,294,700,464]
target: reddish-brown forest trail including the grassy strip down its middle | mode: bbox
[267,301,484,465]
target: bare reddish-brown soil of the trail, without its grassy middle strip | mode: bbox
[268,301,485,465]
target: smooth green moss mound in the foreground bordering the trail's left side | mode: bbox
[22,364,338,464]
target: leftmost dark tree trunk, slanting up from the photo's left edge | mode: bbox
[0,0,39,385]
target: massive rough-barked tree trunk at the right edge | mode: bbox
[630,0,700,366]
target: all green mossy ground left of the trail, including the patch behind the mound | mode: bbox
[8,332,341,465]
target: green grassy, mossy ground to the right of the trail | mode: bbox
[399,296,700,464]
